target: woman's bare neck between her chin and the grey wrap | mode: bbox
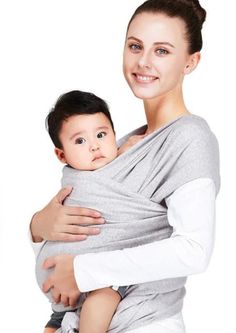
[144,93,190,134]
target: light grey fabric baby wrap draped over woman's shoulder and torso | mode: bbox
[36,115,220,333]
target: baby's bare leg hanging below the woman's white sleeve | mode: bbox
[79,288,121,333]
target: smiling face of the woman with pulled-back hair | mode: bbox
[123,13,195,99]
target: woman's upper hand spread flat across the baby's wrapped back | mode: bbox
[30,187,105,242]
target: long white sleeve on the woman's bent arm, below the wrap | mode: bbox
[74,178,216,292]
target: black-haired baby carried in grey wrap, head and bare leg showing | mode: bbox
[41,91,140,333]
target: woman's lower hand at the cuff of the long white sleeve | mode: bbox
[43,254,80,307]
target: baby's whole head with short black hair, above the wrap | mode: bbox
[46,90,117,170]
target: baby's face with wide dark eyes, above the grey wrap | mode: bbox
[55,112,117,170]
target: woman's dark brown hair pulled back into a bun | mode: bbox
[127,0,206,54]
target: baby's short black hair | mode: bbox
[45,90,115,149]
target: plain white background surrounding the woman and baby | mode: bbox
[0,0,236,333]
